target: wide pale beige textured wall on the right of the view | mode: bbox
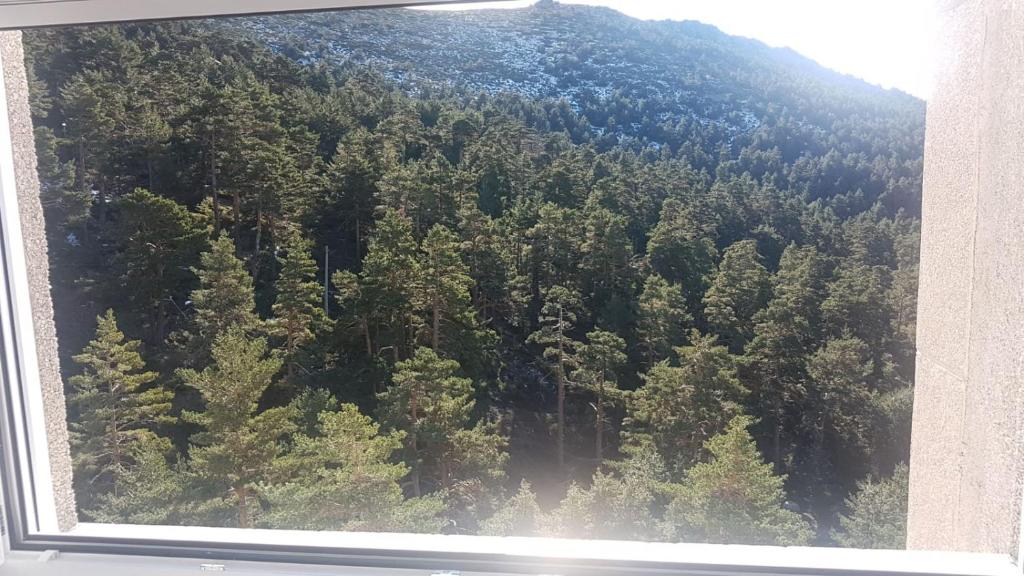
[907,0,1024,557]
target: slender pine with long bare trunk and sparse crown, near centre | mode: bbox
[527,286,582,467]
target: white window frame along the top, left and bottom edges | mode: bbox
[0,0,1021,576]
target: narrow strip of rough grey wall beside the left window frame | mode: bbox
[0,32,78,530]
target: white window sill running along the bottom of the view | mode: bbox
[8,524,1020,576]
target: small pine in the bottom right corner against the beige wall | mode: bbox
[831,464,910,549]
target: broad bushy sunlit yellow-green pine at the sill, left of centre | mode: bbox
[262,404,444,533]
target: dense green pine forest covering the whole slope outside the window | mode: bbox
[25,2,924,548]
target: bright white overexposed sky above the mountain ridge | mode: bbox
[415,0,935,99]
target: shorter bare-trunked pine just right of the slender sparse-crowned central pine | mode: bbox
[573,330,626,462]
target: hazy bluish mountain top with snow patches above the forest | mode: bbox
[226,2,925,187]
